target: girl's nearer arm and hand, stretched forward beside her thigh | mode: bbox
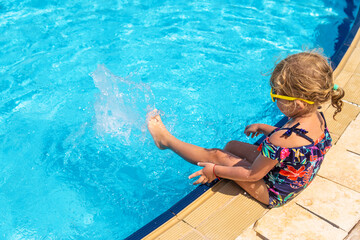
[189,154,278,184]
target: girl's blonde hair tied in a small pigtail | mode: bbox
[270,51,345,118]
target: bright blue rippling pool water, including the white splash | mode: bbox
[0,0,354,239]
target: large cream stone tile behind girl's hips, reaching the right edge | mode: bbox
[296,176,360,232]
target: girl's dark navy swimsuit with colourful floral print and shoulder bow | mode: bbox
[258,113,332,208]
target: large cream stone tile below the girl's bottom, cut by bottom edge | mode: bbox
[255,201,347,240]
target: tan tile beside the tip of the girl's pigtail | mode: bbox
[324,103,360,136]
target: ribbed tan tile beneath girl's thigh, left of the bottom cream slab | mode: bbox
[196,194,267,240]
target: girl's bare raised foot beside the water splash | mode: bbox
[148,109,171,149]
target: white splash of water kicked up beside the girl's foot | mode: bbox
[90,65,155,145]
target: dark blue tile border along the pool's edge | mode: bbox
[125,4,360,240]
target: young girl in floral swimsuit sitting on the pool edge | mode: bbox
[148,52,344,208]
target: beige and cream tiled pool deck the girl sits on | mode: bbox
[140,23,360,240]
